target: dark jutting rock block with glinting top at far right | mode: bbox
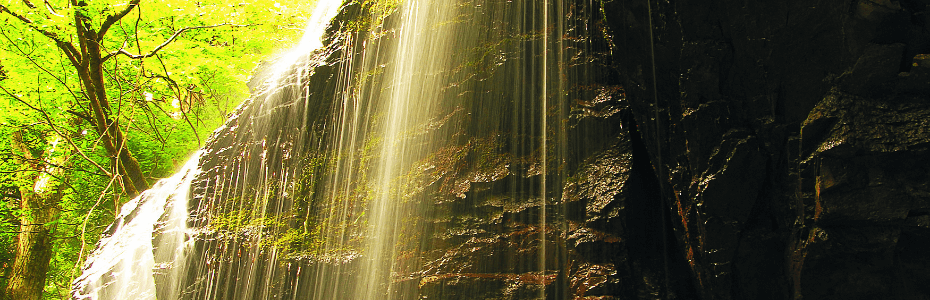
[801,92,930,299]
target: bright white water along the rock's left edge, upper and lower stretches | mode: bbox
[72,0,340,299]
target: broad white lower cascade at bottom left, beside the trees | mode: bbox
[74,152,200,299]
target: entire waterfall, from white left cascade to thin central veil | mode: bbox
[74,0,616,299]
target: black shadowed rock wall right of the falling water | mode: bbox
[602,0,930,299]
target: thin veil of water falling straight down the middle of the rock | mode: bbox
[312,0,562,299]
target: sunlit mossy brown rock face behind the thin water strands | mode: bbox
[174,0,648,299]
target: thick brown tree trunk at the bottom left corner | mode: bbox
[5,132,63,300]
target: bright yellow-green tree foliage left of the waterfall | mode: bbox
[0,0,324,299]
